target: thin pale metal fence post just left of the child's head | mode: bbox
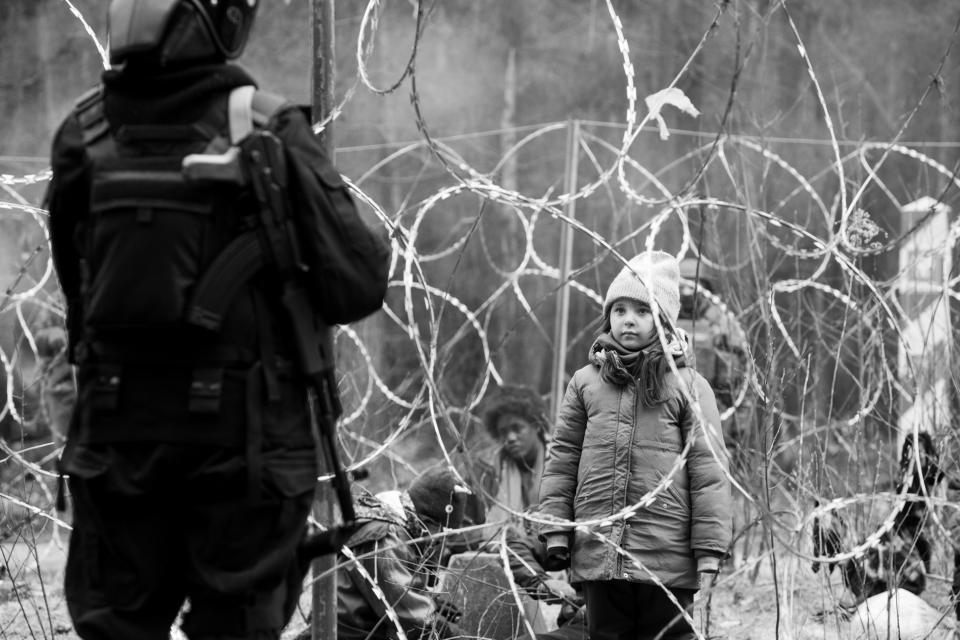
[550,120,580,418]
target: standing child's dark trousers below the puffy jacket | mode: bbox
[583,580,696,640]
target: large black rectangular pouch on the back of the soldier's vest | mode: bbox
[84,162,214,340]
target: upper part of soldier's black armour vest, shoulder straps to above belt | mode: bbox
[76,87,280,362]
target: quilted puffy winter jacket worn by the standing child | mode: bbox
[540,365,732,589]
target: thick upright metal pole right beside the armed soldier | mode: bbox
[310,0,337,640]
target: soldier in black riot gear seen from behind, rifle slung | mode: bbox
[47,0,389,640]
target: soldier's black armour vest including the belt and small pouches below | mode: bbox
[75,87,294,446]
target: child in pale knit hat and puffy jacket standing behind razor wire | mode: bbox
[540,251,732,640]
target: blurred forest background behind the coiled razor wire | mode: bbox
[0,0,960,640]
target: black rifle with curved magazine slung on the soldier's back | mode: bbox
[183,129,356,556]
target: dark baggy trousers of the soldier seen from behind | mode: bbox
[64,447,313,640]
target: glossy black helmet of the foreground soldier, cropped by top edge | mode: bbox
[109,0,259,64]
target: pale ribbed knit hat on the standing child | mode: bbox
[603,251,680,326]
